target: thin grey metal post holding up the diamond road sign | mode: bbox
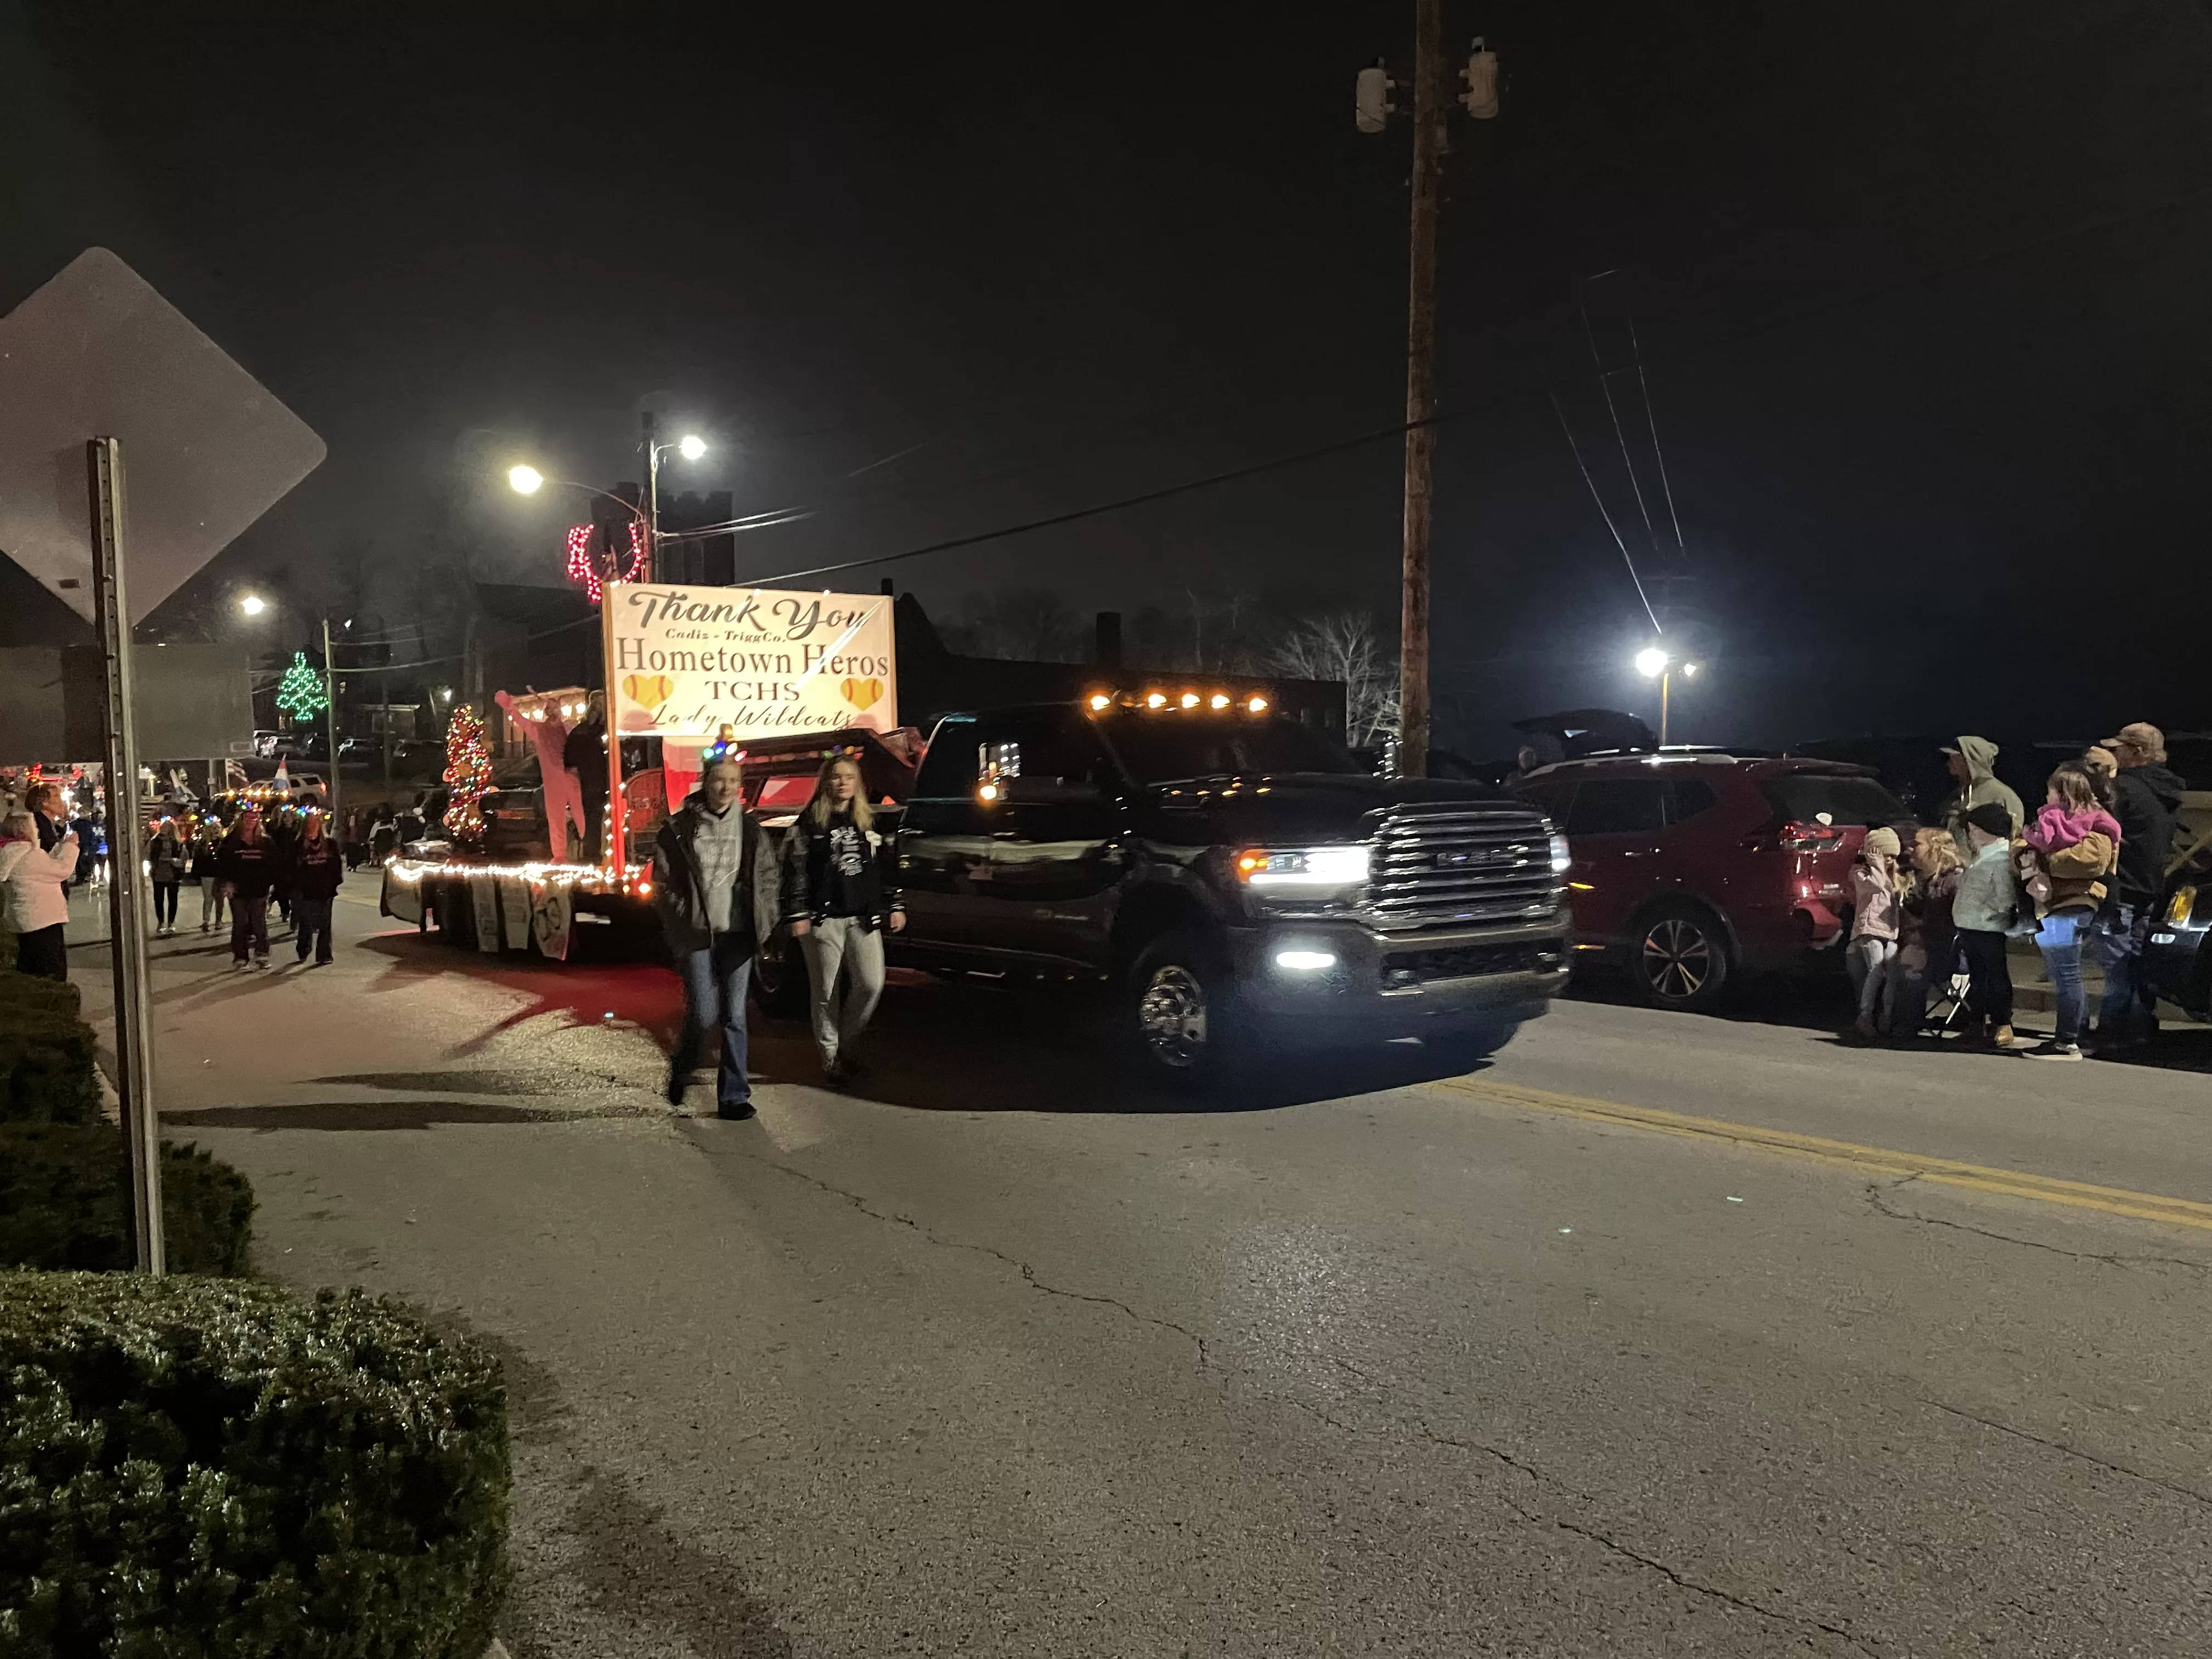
[84,438,168,1278]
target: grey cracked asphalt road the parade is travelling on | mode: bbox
[60,902,2212,1659]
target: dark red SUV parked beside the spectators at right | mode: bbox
[1513,752,1911,1009]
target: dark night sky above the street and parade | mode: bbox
[0,0,2212,752]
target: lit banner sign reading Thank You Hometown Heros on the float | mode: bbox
[604,582,898,741]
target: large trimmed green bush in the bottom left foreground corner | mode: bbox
[0,1274,509,1659]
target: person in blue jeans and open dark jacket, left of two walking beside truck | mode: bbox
[652,759,776,1117]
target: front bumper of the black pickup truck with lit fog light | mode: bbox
[1230,916,1568,1042]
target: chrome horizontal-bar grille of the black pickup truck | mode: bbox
[1367,803,1562,931]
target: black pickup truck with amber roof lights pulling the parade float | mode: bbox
[889,692,1568,1084]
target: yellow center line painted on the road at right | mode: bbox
[1442,1077,2212,1232]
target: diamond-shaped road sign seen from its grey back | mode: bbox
[0,248,328,622]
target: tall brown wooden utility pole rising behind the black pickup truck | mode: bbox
[1398,0,1447,778]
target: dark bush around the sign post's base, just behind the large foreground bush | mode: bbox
[0,1124,255,1278]
